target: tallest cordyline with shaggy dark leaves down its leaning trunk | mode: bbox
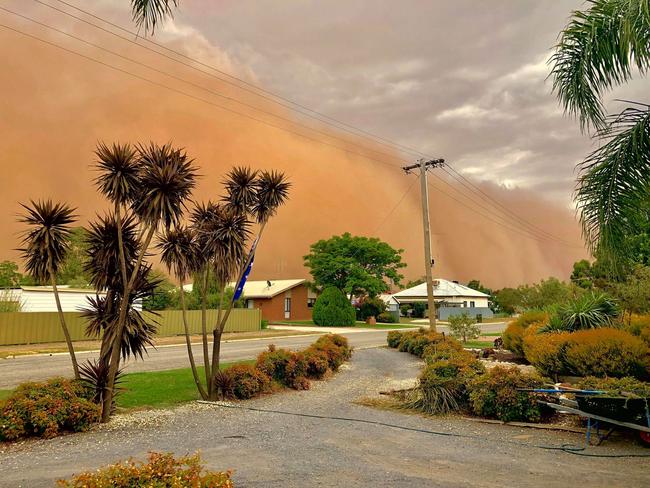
[93,143,196,422]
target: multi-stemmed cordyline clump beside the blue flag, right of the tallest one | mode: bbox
[159,167,290,399]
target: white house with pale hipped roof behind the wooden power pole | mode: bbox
[393,278,493,320]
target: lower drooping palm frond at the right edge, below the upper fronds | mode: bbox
[576,106,650,262]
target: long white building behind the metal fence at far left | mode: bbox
[3,285,107,312]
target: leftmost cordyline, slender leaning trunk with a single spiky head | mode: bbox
[20,200,79,379]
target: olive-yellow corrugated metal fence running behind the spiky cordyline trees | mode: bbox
[0,308,262,346]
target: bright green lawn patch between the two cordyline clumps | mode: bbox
[117,360,255,409]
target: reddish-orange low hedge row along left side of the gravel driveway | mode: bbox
[217,334,352,400]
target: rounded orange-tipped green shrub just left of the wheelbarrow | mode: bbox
[467,366,543,422]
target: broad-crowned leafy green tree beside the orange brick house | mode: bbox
[304,232,406,297]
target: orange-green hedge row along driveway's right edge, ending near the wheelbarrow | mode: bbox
[387,329,543,422]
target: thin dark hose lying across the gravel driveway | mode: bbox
[197,400,650,458]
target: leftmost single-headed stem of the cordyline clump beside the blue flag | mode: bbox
[158,226,208,400]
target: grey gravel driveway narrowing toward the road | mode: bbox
[0,349,650,488]
